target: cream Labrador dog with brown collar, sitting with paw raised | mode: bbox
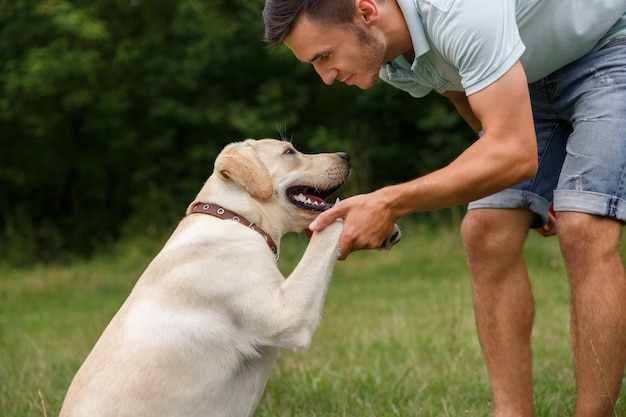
[60,139,400,417]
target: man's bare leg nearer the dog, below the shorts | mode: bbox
[462,209,535,417]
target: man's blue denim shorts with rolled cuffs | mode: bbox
[468,37,626,227]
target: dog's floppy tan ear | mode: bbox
[215,143,274,200]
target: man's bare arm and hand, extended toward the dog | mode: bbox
[310,62,537,259]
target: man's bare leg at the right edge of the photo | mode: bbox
[557,212,626,417]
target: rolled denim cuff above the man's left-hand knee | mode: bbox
[467,189,550,229]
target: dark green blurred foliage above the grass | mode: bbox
[0,0,473,264]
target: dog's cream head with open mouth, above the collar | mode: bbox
[188,139,350,234]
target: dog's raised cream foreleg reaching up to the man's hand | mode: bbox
[276,221,343,351]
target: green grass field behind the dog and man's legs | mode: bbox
[0,216,626,417]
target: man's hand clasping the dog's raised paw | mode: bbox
[309,192,396,260]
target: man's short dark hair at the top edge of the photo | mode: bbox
[263,0,354,46]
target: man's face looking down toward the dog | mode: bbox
[284,16,385,89]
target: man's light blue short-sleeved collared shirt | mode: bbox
[379,0,626,97]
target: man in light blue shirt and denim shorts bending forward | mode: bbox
[264,0,626,417]
